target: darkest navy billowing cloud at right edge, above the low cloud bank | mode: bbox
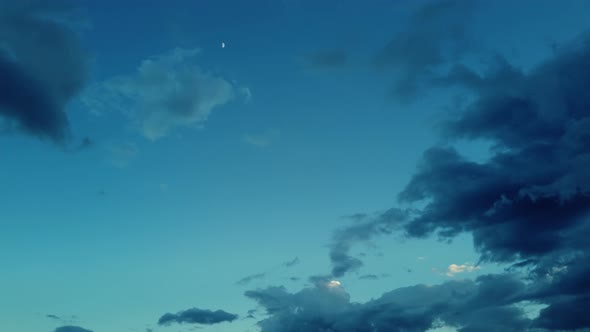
[399,34,590,261]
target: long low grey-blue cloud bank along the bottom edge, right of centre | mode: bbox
[246,275,531,332]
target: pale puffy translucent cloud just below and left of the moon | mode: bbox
[83,48,240,140]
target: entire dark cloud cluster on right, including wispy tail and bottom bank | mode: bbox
[260,1,590,332]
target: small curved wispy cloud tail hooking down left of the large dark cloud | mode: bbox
[330,209,406,277]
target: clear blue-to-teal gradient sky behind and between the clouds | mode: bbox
[0,0,590,332]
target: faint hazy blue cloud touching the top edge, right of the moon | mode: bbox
[375,0,474,101]
